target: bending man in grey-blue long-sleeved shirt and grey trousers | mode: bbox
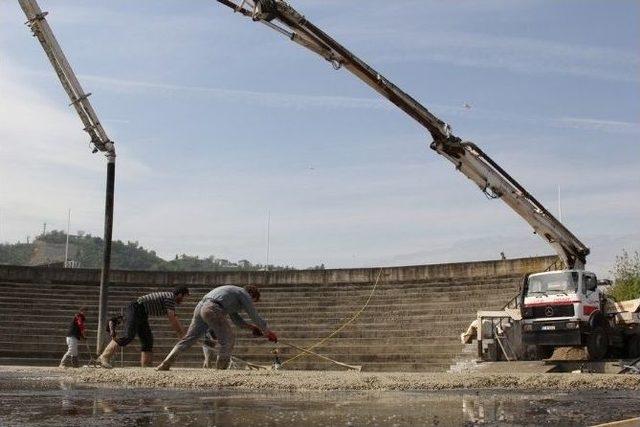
[157,285,278,371]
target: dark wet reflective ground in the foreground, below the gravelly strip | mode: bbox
[0,378,640,427]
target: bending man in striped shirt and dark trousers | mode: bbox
[98,286,189,368]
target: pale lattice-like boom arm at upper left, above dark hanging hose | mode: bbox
[18,0,116,159]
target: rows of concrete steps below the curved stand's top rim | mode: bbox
[0,260,536,372]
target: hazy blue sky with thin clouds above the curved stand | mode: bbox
[0,0,640,277]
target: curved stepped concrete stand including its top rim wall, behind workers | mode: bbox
[0,257,556,372]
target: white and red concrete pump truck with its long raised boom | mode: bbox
[217,0,640,360]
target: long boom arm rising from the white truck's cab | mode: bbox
[217,0,589,269]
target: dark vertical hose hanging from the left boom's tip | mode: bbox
[96,155,116,354]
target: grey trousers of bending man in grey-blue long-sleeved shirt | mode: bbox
[174,300,236,360]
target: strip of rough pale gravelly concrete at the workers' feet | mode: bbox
[5,366,640,391]
